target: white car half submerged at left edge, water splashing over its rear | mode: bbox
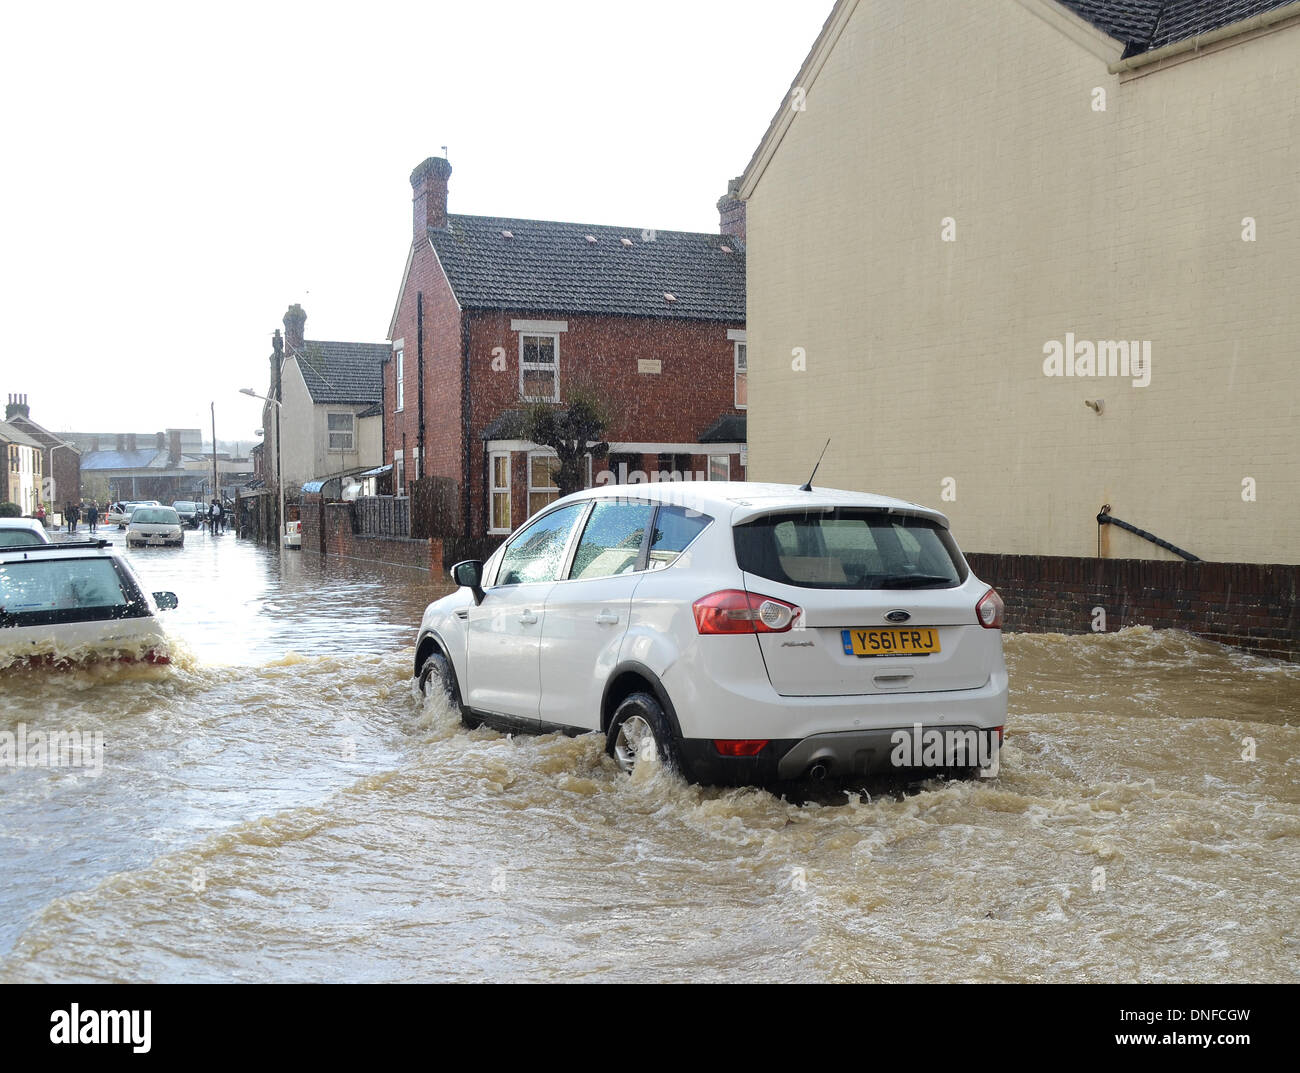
[0,540,177,667]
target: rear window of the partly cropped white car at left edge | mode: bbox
[0,558,143,626]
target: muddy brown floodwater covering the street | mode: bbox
[0,531,1300,982]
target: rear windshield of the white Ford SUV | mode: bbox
[735,509,966,589]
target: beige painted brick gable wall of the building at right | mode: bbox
[748,0,1300,563]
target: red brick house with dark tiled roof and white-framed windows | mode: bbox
[384,157,746,536]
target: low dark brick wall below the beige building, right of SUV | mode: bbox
[966,553,1300,662]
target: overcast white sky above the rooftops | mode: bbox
[0,0,832,440]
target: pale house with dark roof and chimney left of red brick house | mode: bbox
[261,303,389,499]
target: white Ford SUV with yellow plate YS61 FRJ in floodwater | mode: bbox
[415,483,1008,784]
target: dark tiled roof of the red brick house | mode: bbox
[429,215,745,323]
